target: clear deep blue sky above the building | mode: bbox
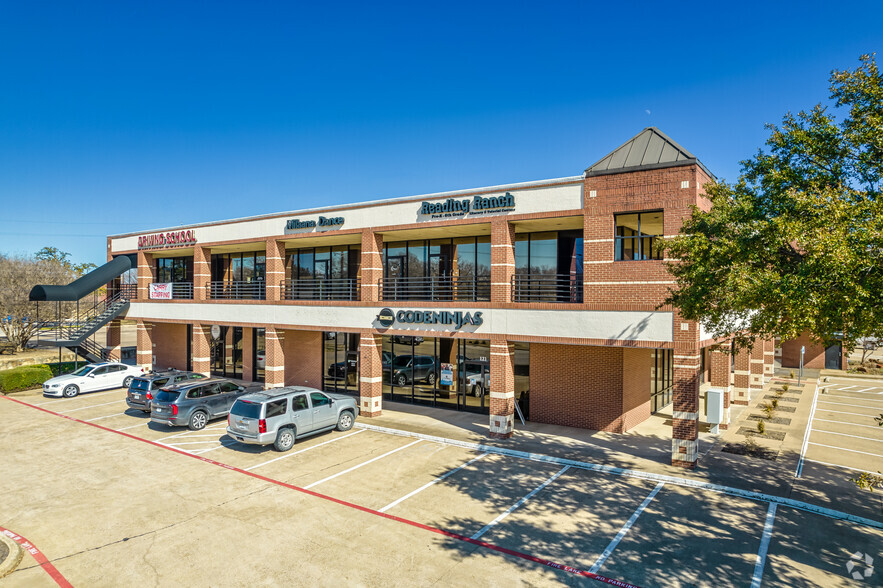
[0,0,883,263]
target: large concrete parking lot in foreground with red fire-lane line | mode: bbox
[0,386,883,586]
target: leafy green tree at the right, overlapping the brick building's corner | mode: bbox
[666,55,883,348]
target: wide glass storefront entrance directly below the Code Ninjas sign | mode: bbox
[382,335,491,413]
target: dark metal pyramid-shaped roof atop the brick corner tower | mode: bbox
[586,127,714,178]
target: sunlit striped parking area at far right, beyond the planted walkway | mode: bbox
[804,378,883,473]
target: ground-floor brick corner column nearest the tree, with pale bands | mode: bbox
[671,313,702,469]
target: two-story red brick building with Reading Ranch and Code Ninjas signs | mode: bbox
[107,128,772,467]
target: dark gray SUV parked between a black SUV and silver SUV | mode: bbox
[150,378,246,431]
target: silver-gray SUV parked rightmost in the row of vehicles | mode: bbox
[227,386,359,451]
